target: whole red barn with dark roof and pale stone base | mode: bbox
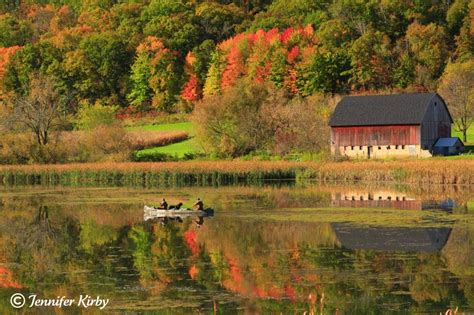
[329,93,453,158]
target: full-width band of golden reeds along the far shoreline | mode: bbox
[0,159,474,186]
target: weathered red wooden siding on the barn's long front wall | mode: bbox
[332,125,420,146]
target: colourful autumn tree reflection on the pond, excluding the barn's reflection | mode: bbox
[0,198,474,314]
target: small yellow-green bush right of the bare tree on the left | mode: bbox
[74,102,118,130]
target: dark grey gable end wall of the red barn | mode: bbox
[420,95,451,150]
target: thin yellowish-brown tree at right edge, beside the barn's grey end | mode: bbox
[439,60,474,142]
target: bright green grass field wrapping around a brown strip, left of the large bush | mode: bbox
[127,122,203,159]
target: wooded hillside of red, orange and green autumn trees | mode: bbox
[0,0,474,112]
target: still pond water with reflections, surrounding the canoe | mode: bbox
[0,185,474,314]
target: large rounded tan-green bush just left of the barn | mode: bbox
[193,81,329,157]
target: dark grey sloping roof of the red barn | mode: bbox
[329,93,444,127]
